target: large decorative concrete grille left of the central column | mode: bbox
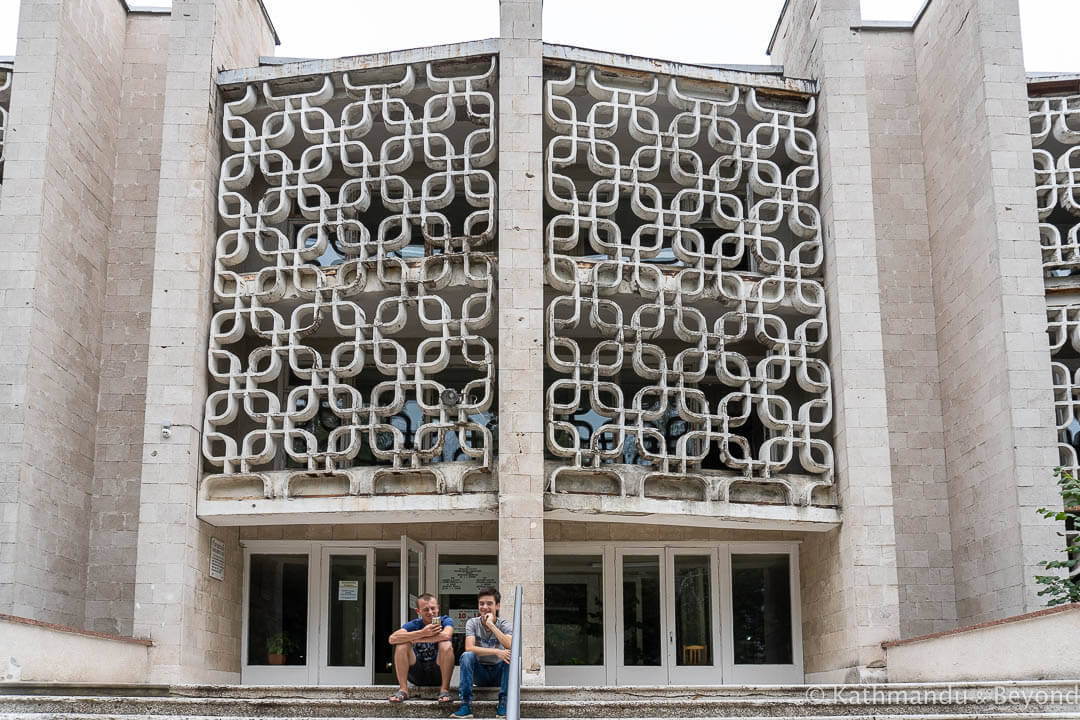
[203,56,497,497]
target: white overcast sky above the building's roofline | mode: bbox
[0,0,1080,72]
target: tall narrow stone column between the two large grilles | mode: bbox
[498,0,544,684]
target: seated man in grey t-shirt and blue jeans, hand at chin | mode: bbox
[450,587,513,718]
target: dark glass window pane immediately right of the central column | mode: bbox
[543,555,604,665]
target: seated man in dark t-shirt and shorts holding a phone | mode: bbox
[389,593,454,704]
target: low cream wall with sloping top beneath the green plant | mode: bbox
[881,602,1080,682]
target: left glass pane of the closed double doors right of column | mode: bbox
[622,555,660,666]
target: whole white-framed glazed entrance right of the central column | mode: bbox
[544,542,804,685]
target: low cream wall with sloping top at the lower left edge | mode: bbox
[0,614,152,683]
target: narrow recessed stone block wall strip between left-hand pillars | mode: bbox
[84,8,168,636]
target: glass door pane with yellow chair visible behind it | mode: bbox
[675,555,713,665]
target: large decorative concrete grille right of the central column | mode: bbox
[544,64,833,504]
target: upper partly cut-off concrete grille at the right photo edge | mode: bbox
[1028,95,1080,284]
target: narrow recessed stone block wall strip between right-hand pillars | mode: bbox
[861,28,956,637]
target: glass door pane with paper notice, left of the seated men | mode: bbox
[326,555,367,667]
